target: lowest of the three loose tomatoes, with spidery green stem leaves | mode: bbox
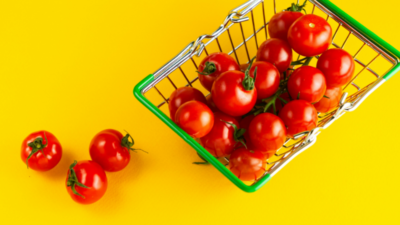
[65,160,108,204]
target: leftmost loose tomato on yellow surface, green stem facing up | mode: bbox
[21,131,62,171]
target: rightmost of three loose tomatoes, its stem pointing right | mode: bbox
[89,129,141,172]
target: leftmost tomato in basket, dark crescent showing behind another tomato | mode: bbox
[168,87,207,122]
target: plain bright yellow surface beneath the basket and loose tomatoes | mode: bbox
[0,0,400,224]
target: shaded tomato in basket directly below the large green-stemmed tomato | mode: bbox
[200,112,239,158]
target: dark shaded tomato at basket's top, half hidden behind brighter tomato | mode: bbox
[268,11,304,41]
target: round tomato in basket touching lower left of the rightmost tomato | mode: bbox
[288,66,326,103]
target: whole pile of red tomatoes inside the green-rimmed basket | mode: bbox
[169,2,354,181]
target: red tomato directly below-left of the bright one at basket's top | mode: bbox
[257,38,292,72]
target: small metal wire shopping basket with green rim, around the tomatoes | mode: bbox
[134,0,400,192]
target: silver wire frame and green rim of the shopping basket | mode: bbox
[134,0,400,192]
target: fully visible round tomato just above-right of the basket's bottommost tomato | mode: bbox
[249,113,286,153]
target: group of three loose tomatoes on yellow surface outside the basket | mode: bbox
[21,128,145,204]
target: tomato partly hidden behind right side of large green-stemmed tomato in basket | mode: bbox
[249,61,280,99]
